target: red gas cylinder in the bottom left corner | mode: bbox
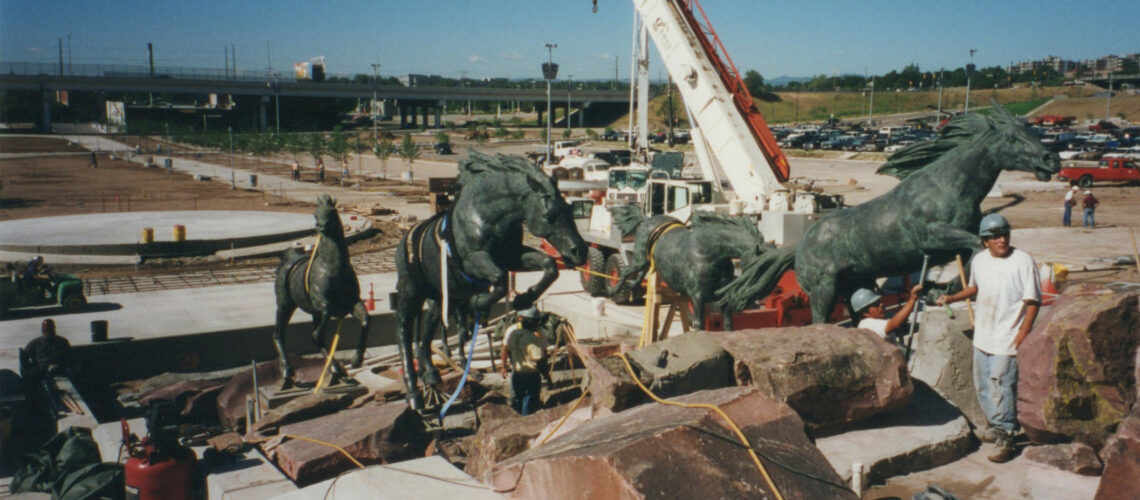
[123,444,198,500]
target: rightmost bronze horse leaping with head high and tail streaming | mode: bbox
[717,103,1060,322]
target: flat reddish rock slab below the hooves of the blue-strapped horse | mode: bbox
[262,402,431,483]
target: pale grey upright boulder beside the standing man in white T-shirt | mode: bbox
[910,308,988,427]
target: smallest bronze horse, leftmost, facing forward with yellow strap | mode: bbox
[274,194,371,388]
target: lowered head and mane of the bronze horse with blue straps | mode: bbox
[457,150,588,265]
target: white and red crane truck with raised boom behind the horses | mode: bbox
[547,0,842,329]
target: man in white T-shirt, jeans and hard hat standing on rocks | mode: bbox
[937,214,1041,464]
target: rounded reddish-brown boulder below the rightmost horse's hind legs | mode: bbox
[709,325,914,431]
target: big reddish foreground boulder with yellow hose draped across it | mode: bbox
[486,387,855,499]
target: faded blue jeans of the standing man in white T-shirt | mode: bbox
[974,347,1019,434]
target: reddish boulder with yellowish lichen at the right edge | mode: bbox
[1017,284,1140,449]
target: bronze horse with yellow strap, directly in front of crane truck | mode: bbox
[606,205,775,330]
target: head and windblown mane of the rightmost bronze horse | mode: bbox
[878,100,1061,181]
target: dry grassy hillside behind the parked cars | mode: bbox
[610,87,1140,131]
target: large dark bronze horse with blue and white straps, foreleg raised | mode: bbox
[396,150,587,410]
